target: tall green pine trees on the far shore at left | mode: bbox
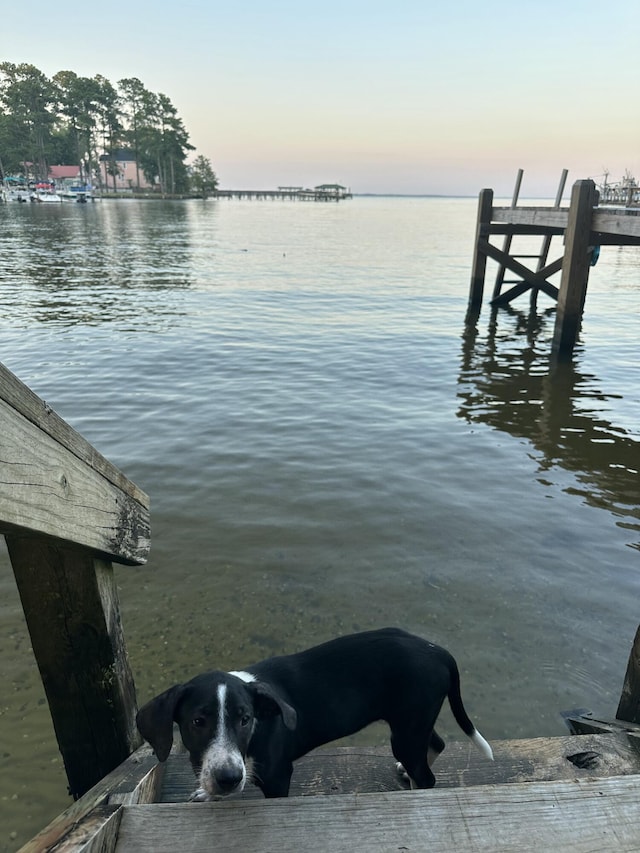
[0,62,217,193]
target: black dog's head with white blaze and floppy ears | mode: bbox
[136,671,296,798]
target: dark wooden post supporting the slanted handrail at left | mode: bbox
[6,535,140,797]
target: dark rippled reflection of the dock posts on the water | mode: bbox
[458,307,640,549]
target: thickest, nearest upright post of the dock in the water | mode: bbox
[551,180,597,361]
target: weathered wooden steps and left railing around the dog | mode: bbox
[0,326,640,853]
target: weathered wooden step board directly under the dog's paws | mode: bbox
[161,732,640,802]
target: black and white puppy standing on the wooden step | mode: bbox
[137,628,493,800]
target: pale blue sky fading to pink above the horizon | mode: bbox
[0,0,640,196]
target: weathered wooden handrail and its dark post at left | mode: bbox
[0,365,150,798]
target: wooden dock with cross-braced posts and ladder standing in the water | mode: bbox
[466,171,640,361]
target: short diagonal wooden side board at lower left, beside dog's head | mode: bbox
[19,745,164,853]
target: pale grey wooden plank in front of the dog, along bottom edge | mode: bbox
[116,776,640,853]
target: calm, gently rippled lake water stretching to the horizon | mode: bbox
[0,198,640,851]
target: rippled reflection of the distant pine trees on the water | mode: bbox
[0,201,191,327]
